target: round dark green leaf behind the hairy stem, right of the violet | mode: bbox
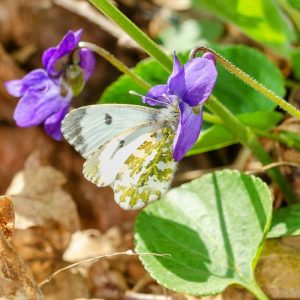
[214,46,285,114]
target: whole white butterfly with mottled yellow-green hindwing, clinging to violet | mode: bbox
[61,104,179,210]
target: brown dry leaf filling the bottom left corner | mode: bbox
[0,231,42,300]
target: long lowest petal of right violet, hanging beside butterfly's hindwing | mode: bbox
[173,101,203,161]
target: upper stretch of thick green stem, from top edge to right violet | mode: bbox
[89,0,172,71]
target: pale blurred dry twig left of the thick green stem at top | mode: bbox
[53,0,142,51]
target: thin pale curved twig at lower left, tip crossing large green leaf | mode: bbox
[39,250,171,288]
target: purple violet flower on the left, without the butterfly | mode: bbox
[5,29,95,140]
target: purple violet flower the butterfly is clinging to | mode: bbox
[143,53,217,161]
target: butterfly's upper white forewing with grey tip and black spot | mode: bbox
[62,104,158,158]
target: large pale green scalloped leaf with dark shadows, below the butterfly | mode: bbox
[135,170,272,299]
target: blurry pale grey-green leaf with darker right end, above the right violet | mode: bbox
[158,19,224,52]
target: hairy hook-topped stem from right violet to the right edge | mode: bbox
[191,46,300,119]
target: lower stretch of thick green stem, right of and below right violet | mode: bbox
[208,96,297,203]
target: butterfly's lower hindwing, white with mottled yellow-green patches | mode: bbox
[113,128,176,209]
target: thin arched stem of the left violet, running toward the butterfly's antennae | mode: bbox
[79,42,151,90]
